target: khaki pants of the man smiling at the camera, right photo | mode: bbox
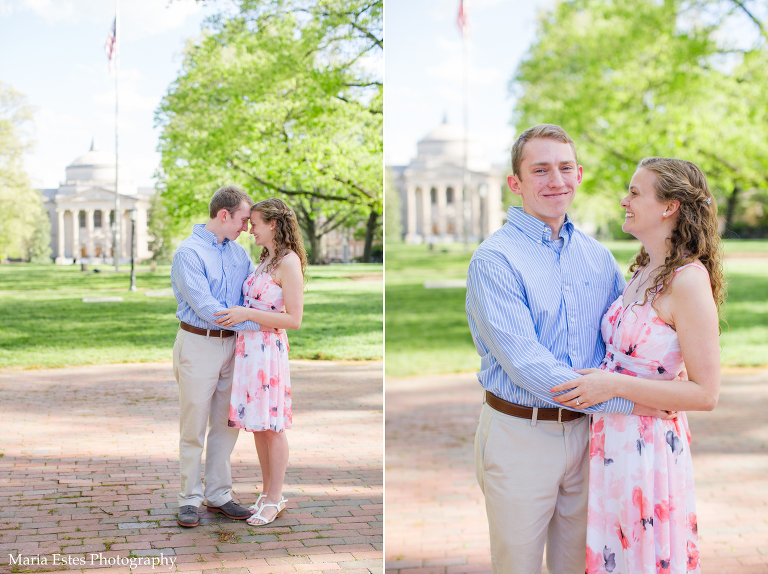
[475,404,589,574]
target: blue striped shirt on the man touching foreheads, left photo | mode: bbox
[171,224,260,331]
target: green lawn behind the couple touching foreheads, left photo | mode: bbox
[0,264,383,368]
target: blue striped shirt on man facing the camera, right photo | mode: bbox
[467,207,634,414]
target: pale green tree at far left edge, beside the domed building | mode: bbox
[0,82,50,261]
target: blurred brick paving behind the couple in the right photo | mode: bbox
[385,369,768,574]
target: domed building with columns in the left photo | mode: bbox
[42,141,155,265]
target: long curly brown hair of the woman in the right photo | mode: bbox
[629,157,726,311]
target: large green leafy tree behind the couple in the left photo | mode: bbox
[157,0,383,263]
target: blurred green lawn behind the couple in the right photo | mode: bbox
[385,241,768,376]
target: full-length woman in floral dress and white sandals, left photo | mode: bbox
[216,198,307,526]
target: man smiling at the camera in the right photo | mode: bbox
[467,124,667,574]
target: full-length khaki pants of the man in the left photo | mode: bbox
[173,329,239,507]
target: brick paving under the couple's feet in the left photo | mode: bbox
[0,361,383,574]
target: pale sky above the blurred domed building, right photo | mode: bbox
[384,0,554,169]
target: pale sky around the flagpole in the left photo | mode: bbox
[0,0,225,188]
